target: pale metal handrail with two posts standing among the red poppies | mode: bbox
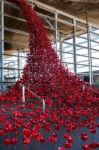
[20,84,46,112]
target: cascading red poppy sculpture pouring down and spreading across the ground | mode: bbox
[0,0,99,150]
